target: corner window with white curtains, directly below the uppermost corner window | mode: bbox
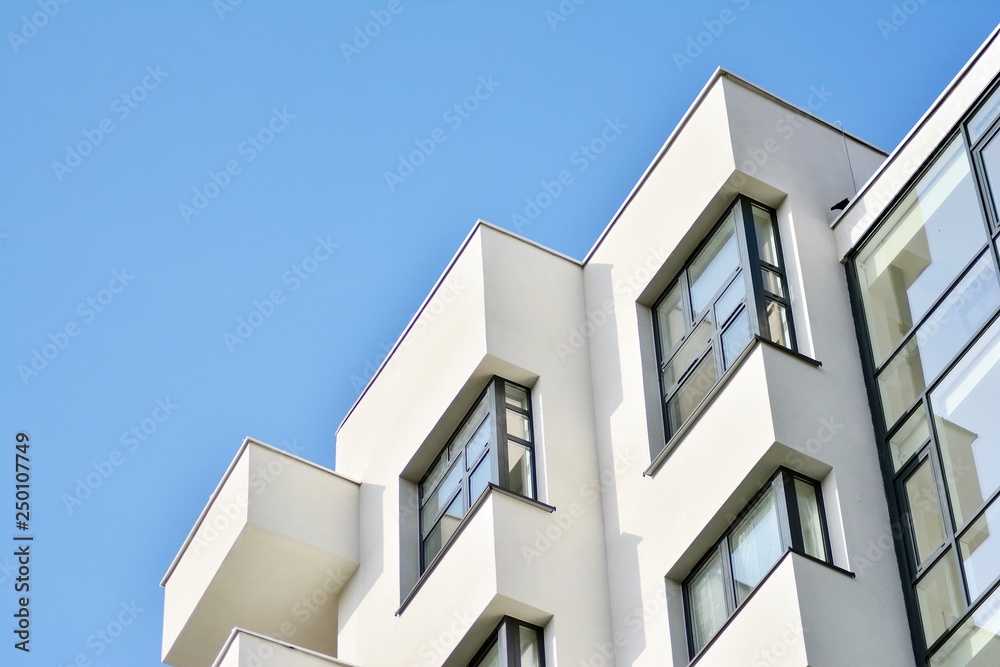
[684,468,830,658]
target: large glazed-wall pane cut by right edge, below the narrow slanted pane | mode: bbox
[931,322,1000,527]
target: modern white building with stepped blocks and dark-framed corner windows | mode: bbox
[163,24,1000,667]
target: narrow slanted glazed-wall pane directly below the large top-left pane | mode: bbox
[878,253,1000,424]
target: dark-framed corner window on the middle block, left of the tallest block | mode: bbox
[420,377,535,572]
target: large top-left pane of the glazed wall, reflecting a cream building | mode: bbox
[856,137,986,365]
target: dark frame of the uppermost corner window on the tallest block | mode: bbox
[652,195,798,446]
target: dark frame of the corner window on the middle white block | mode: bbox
[417,375,538,573]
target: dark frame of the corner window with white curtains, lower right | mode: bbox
[681,466,833,660]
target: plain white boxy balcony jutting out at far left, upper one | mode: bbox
[161,438,360,667]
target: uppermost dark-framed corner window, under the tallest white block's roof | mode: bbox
[653,197,795,448]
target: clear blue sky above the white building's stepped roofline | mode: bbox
[0,0,1000,666]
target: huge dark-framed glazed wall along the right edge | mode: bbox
[848,78,1000,667]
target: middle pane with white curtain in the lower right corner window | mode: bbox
[729,489,785,604]
